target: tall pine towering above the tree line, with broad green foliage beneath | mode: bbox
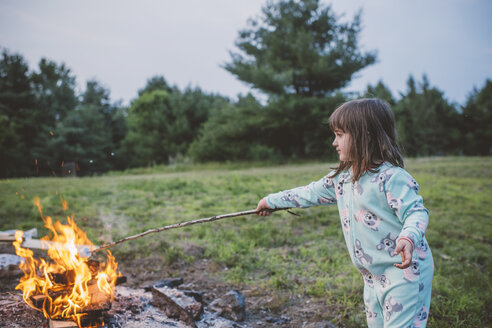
[206,0,375,161]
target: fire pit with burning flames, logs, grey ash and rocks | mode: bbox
[8,199,250,328]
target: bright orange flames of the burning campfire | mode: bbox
[13,198,121,327]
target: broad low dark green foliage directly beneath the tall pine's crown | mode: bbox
[190,94,345,161]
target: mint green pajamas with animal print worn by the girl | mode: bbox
[266,163,434,328]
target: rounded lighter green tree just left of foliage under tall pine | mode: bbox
[123,84,228,167]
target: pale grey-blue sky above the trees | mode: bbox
[0,0,492,104]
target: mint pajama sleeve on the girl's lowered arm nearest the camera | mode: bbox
[385,170,429,246]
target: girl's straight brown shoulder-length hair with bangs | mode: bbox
[329,98,403,182]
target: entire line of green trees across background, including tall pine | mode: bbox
[0,0,492,178]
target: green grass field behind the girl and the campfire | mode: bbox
[0,157,492,328]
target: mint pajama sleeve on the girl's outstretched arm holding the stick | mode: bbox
[266,175,337,209]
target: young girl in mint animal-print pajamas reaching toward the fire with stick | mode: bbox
[257,99,434,328]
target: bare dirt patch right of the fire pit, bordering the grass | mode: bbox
[120,258,344,328]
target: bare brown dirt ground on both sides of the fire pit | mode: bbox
[0,251,343,328]
